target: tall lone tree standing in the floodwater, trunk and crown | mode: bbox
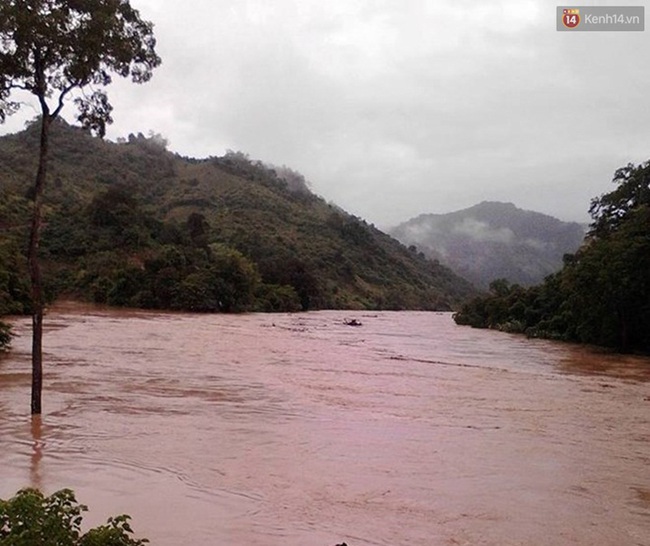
[0,0,160,414]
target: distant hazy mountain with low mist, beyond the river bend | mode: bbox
[389,201,585,288]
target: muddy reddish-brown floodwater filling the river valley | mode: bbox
[0,304,650,546]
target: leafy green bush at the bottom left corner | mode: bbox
[0,489,149,546]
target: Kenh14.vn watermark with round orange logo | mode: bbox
[557,6,645,32]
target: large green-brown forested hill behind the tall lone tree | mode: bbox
[0,117,473,314]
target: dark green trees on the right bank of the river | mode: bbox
[454,162,650,353]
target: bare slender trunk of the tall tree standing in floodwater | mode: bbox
[27,113,52,415]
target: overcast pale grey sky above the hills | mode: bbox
[0,0,650,228]
